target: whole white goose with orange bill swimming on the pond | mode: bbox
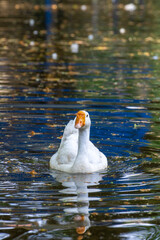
[50,111,107,173]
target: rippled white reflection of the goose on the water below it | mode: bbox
[51,171,103,234]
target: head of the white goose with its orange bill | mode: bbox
[75,110,91,129]
